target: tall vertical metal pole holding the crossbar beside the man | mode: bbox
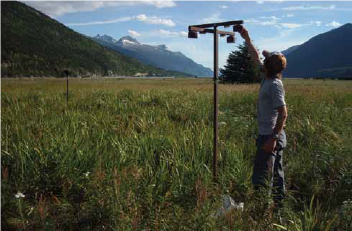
[213,26,219,180]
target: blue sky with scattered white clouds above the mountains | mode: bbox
[20,0,352,68]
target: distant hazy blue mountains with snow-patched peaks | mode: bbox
[92,35,213,77]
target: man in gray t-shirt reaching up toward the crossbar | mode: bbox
[240,28,287,208]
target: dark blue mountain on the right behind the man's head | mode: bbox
[283,23,352,78]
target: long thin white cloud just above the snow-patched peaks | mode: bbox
[66,14,176,27]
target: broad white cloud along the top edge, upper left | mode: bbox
[19,0,176,16]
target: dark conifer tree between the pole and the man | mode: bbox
[220,43,260,83]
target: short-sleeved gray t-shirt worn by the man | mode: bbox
[258,78,286,135]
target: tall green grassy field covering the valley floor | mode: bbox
[0,79,352,230]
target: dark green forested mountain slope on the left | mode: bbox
[0,0,187,77]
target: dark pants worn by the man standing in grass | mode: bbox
[252,131,287,205]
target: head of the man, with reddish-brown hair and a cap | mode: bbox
[263,50,287,79]
